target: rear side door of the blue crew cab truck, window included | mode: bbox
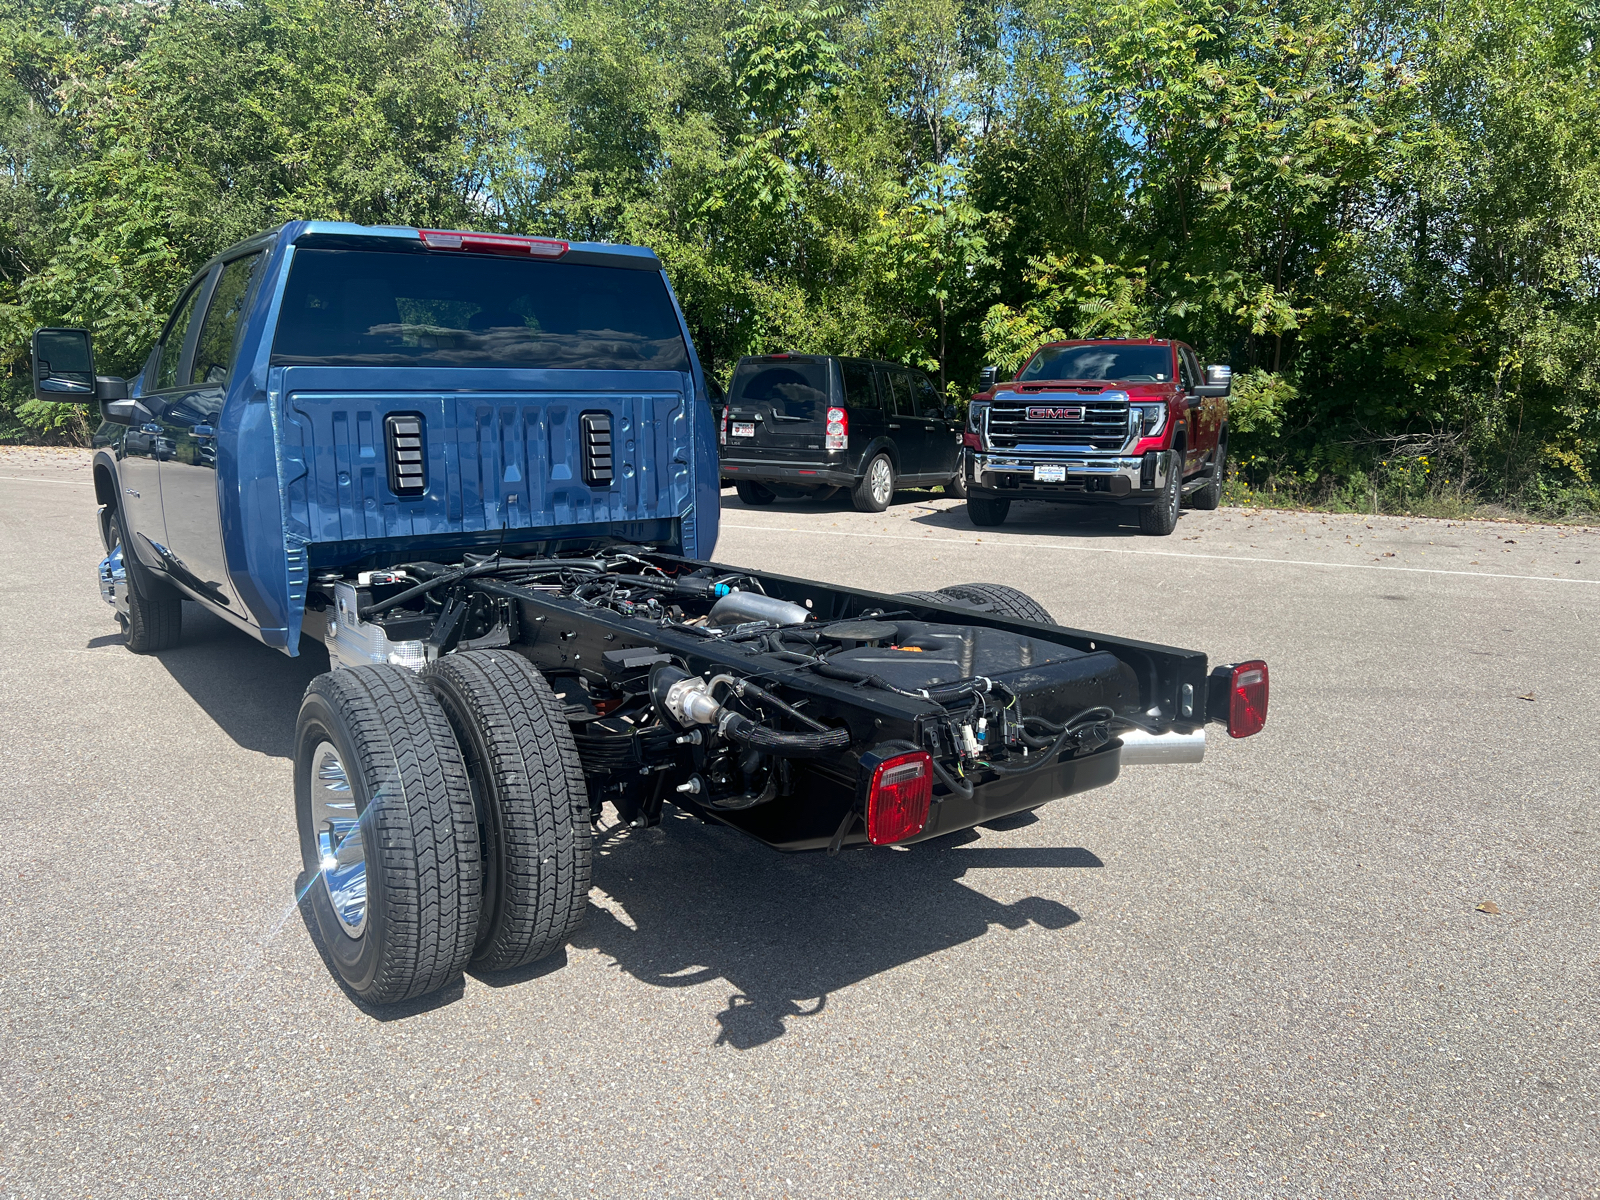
[157,251,262,613]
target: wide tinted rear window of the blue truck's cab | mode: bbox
[272,248,690,371]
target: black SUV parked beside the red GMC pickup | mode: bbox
[722,354,962,512]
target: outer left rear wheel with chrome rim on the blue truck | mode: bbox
[294,666,482,1005]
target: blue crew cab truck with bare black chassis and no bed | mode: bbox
[34,221,1267,1003]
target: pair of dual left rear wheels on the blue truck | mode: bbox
[294,650,592,1005]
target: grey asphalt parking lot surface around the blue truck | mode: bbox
[0,451,1600,1197]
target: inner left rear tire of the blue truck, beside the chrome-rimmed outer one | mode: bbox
[422,650,594,971]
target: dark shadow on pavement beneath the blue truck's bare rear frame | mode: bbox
[553,810,1102,1050]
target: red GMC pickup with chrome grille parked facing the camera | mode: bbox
[962,338,1232,534]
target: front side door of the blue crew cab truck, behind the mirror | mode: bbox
[117,277,208,570]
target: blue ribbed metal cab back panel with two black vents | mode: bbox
[280,366,698,568]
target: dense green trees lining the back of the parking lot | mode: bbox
[0,0,1600,509]
